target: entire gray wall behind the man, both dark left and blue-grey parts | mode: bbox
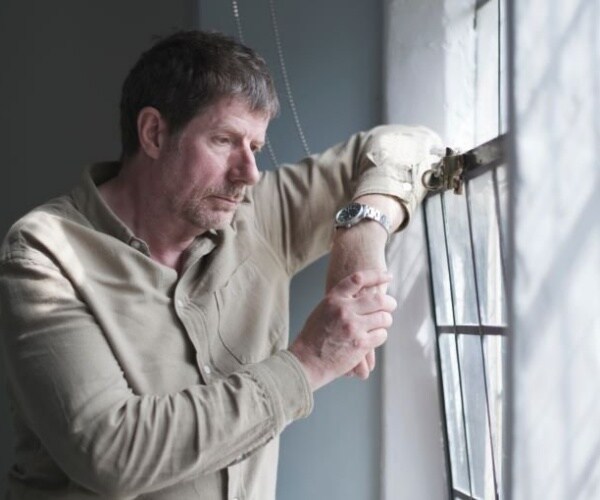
[0,0,382,500]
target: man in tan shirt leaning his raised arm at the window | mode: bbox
[0,32,439,500]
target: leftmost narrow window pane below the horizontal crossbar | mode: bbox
[439,334,471,492]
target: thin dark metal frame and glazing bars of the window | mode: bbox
[423,0,510,500]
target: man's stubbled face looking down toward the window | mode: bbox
[158,98,269,232]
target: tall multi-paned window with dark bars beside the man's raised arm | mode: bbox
[424,0,508,500]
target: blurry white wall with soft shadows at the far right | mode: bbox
[511,0,600,500]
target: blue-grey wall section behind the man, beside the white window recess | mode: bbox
[200,0,382,500]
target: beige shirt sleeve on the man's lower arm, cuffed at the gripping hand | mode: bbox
[0,255,312,497]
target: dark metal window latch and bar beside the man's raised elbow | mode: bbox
[421,134,506,194]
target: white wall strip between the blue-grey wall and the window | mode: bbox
[382,0,475,500]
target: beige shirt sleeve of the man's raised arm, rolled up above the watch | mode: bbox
[252,125,439,274]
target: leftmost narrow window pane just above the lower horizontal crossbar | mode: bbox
[425,195,453,325]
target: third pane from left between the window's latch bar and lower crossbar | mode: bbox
[467,172,506,325]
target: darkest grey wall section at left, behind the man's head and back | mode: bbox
[0,0,196,496]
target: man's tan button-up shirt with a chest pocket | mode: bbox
[0,130,412,500]
